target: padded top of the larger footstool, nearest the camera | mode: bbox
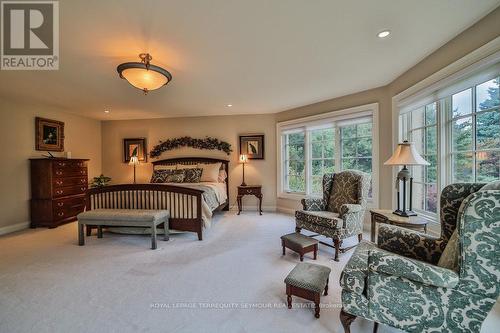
[285,263,331,293]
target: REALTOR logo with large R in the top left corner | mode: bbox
[0,0,59,70]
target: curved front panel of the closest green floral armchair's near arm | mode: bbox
[340,241,377,294]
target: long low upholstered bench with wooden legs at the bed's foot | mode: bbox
[77,209,170,250]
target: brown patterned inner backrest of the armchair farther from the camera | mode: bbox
[327,170,363,213]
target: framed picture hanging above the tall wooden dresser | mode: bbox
[35,117,64,151]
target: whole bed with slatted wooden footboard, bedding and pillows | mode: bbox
[86,157,229,240]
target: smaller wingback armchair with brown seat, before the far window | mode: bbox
[295,170,370,261]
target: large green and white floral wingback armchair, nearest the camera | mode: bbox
[340,184,500,332]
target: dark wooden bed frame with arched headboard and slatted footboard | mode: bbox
[85,157,229,241]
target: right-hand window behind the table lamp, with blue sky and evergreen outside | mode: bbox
[399,73,500,215]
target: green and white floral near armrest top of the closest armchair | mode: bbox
[368,249,459,288]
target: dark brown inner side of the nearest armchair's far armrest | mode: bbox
[377,225,446,264]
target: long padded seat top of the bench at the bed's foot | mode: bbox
[77,209,169,222]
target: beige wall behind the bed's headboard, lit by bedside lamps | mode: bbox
[102,115,276,209]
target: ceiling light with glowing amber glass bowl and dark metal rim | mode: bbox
[116,53,172,94]
